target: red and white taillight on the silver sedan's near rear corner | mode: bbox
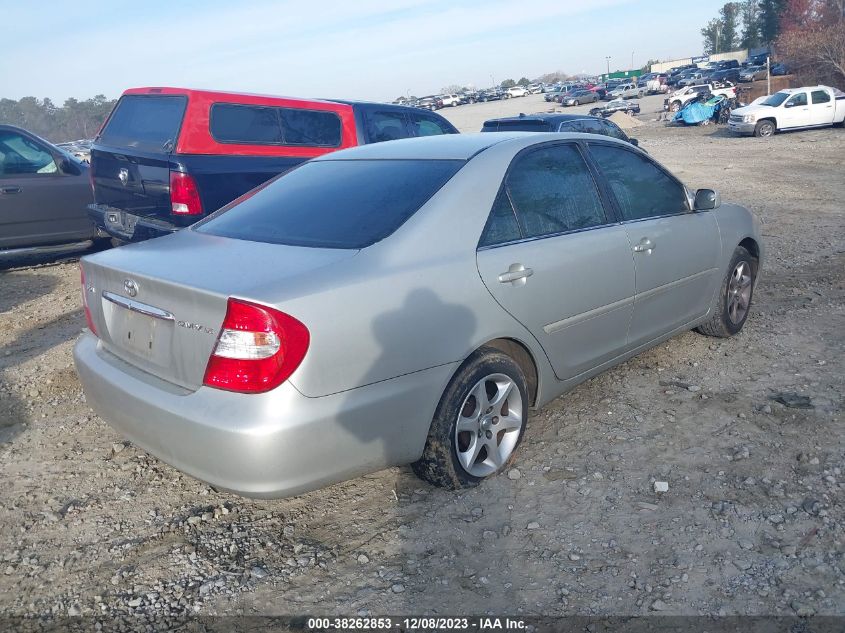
[203,299,311,393]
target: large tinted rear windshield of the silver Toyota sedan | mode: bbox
[195,160,465,249]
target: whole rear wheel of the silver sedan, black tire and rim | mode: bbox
[411,347,529,490]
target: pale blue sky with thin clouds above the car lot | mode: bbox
[0,0,724,103]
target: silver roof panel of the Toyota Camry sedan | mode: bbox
[311,130,622,163]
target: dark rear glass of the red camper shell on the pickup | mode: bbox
[98,95,188,152]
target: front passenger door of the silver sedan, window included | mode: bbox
[589,142,721,347]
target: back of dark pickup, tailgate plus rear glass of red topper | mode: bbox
[91,95,188,223]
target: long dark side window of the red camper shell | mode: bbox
[209,103,341,147]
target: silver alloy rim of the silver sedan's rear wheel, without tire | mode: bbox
[454,374,524,477]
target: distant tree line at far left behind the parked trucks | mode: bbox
[0,95,115,143]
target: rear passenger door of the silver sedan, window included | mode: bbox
[477,143,634,379]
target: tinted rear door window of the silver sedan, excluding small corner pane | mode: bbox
[498,145,607,237]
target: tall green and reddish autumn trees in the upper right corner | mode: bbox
[701,0,845,87]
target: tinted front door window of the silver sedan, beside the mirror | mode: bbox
[590,145,688,220]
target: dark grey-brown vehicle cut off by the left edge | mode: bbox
[0,125,100,255]
